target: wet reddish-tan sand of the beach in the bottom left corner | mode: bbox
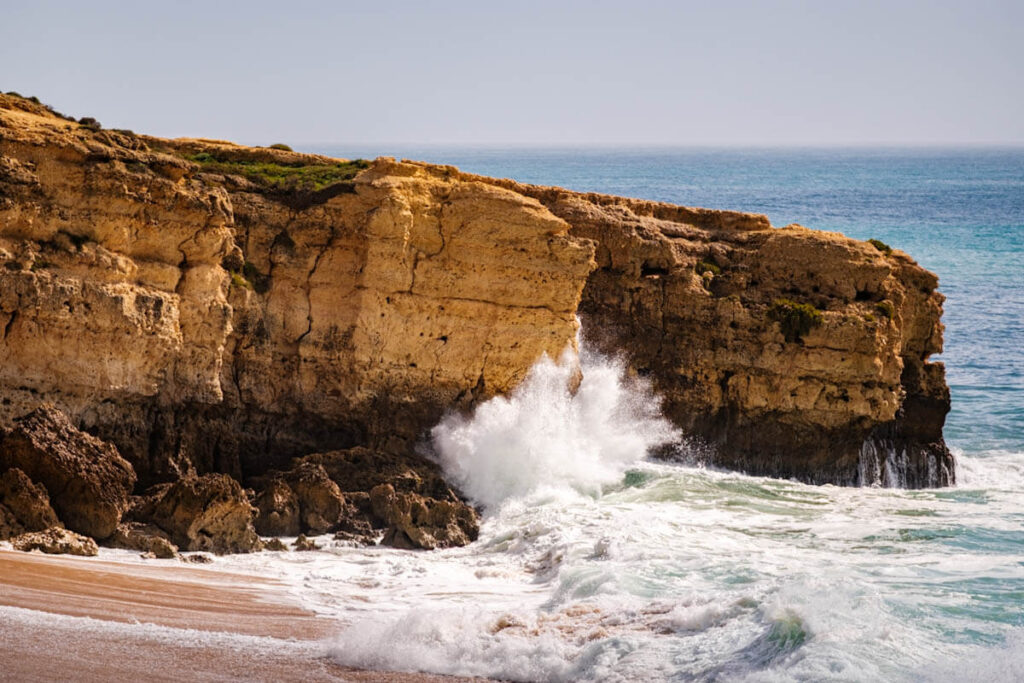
[0,550,491,683]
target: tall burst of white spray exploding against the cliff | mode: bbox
[432,349,681,508]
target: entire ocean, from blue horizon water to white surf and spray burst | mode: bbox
[169,146,1024,681]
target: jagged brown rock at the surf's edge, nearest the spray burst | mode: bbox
[370,484,480,550]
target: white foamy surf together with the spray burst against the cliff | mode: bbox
[88,342,1024,682]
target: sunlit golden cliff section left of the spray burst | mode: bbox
[0,96,593,491]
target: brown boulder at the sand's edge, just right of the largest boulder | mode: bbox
[130,474,261,555]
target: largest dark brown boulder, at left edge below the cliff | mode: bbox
[0,404,135,540]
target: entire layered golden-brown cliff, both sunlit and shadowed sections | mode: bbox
[0,95,952,489]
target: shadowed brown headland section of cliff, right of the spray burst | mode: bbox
[460,179,954,487]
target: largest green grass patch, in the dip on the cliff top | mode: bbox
[185,152,370,191]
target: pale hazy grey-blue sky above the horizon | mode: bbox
[0,0,1024,145]
